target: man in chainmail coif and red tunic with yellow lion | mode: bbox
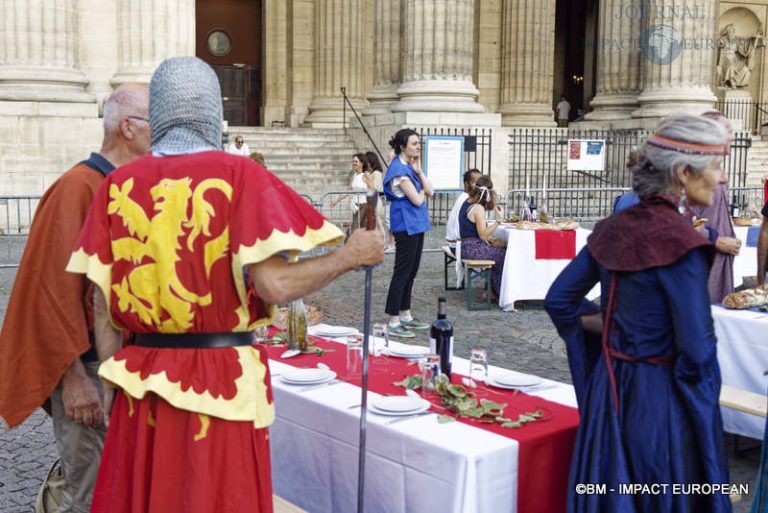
[68,57,384,513]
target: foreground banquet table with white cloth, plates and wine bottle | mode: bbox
[268,341,578,513]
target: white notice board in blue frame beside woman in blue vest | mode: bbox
[424,135,464,191]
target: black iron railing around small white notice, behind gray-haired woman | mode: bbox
[509,128,752,189]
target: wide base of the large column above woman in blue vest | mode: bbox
[392,80,485,112]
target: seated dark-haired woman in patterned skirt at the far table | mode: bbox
[457,176,507,297]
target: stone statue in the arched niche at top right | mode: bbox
[717,23,765,89]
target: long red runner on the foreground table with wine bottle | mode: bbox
[260,337,579,513]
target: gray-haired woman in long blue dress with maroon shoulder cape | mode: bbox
[544,115,731,513]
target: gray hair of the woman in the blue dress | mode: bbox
[632,114,728,195]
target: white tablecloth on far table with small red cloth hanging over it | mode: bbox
[497,227,600,311]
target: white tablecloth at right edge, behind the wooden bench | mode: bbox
[712,306,768,440]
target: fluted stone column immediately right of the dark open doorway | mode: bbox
[586,0,645,121]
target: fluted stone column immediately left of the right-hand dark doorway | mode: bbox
[499,0,556,127]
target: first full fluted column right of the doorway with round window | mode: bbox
[305,0,365,126]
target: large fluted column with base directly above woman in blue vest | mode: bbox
[392,0,484,112]
